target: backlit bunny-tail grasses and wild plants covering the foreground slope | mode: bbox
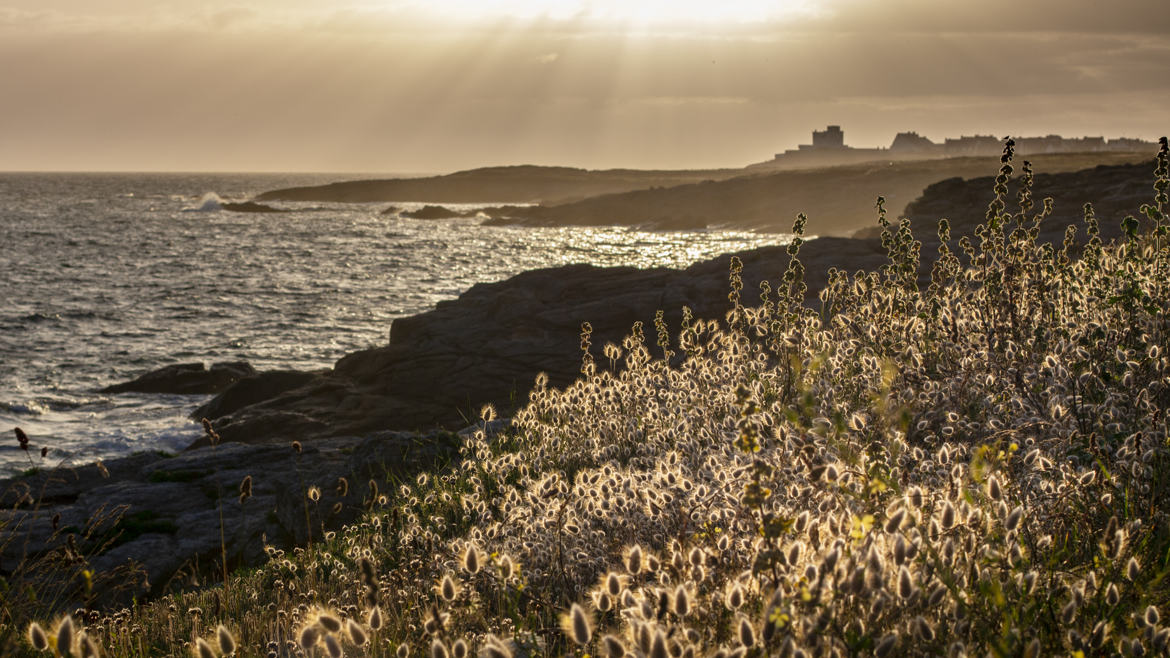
[0,138,1170,658]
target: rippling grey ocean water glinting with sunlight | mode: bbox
[0,173,784,475]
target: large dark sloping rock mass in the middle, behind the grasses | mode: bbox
[191,238,885,443]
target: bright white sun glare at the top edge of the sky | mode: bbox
[407,0,817,26]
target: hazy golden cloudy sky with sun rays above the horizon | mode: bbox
[0,0,1170,173]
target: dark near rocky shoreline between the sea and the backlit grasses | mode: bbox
[0,158,1152,596]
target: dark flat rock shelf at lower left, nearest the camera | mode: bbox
[0,423,475,603]
